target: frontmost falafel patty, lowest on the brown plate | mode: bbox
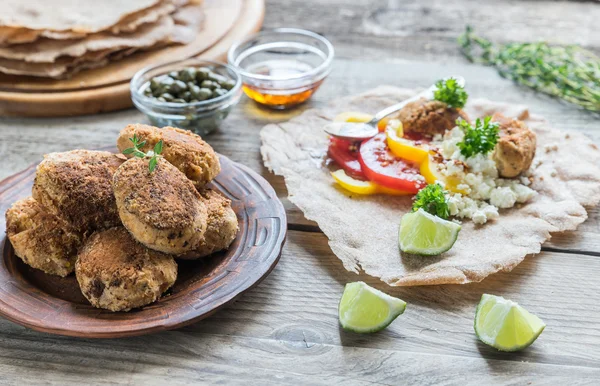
[75,227,177,311]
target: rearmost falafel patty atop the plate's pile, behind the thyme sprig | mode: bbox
[117,124,221,188]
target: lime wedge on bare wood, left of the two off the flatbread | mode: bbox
[338,281,406,334]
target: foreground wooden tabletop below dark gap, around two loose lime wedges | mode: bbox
[0,231,600,385]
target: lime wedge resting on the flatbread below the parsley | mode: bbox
[398,209,460,255]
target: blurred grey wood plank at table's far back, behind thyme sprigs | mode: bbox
[265,0,600,62]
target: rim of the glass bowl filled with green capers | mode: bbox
[129,56,242,109]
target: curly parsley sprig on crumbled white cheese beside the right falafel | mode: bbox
[456,117,500,158]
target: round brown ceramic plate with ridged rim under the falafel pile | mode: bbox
[0,156,287,338]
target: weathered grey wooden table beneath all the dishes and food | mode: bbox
[0,0,600,385]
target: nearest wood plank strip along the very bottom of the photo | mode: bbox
[0,333,599,385]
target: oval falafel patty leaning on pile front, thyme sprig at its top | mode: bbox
[113,158,208,255]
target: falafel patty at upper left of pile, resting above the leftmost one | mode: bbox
[32,150,124,233]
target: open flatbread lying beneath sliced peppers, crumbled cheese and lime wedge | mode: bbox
[260,86,600,286]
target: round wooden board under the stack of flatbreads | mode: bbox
[0,0,265,117]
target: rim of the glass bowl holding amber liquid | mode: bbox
[227,28,335,81]
